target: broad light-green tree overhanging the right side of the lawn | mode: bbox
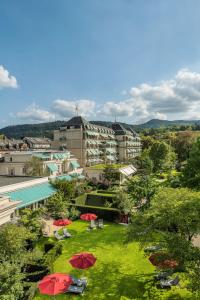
[129,188,200,265]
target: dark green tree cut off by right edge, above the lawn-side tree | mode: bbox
[182,138,200,189]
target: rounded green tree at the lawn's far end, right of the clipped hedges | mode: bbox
[127,176,158,209]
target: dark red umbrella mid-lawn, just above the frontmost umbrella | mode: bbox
[69,252,97,269]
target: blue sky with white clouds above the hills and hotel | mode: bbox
[0,0,200,128]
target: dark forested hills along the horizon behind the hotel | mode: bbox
[0,119,200,139]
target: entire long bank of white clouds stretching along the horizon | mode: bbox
[13,69,200,124]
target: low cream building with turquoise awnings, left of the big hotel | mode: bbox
[0,150,80,176]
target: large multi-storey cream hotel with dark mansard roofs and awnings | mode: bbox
[54,116,141,167]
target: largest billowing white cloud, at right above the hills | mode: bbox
[101,69,200,123]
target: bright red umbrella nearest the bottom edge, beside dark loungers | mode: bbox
[38,273,73,295]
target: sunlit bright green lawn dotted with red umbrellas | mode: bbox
[34,221,194,300]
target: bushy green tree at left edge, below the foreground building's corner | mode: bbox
[0,224,30,261]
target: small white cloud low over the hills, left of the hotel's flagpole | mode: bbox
[16,103,56,122]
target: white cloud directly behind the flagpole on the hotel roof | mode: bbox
[53,99,95,119]
